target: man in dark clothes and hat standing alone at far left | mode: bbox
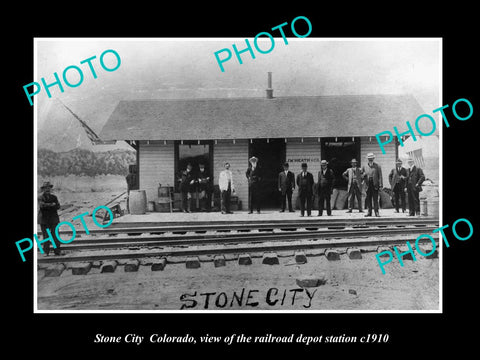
[38,181,60,256]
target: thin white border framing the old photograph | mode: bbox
[33,37,443,314]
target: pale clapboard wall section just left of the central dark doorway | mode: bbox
[213,140,248,210]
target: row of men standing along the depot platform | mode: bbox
[180,153,425,217]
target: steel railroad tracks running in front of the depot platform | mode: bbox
[38,218,438,264]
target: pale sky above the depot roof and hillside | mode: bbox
[35,37,443,151]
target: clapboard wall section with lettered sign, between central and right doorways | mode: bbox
[285,138,321,203]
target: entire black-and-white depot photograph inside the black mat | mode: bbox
[33,38,440,313]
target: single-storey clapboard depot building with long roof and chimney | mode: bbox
[99,79,424,209]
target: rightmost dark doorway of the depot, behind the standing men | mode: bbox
[321,137,361,190]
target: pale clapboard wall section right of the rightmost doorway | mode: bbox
[357,136,396,188]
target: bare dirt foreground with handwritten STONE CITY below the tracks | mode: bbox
[38,252,439,311]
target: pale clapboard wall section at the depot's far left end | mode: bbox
[139,141,175,201]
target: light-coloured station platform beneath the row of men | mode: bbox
[110,209,438,228]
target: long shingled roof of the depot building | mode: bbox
[99,95,423,140]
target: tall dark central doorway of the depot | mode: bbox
[248,138,287,210]
